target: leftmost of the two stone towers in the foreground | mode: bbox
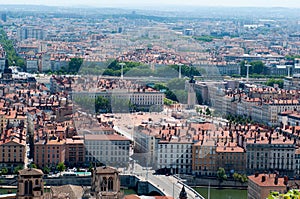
[17,168,44,199]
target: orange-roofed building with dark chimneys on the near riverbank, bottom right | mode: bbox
[248,174,287,199]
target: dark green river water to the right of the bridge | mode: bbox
[194,187,247,199]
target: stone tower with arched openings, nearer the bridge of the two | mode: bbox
[91,167,121,199]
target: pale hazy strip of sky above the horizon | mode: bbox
[0,0,300,8]
